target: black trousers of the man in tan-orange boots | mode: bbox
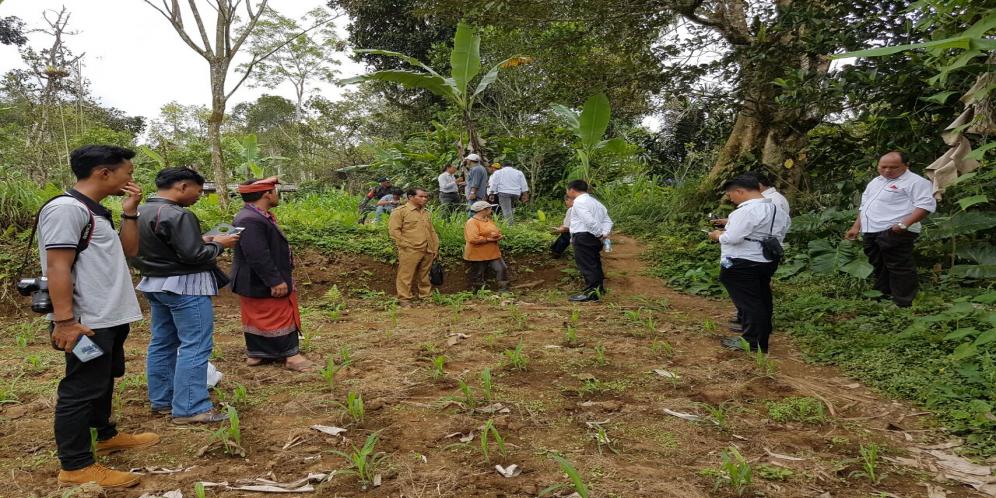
[55,324,129,470]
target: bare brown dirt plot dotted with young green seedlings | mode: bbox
[0,237,974,497]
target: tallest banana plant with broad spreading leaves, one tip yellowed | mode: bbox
[341,21,530,157]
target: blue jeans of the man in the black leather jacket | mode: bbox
[145,292,214,417]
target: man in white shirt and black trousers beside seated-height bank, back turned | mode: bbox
[567,180,612,302]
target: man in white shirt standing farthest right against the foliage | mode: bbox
[844,151,937,307]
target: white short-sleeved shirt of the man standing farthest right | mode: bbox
[859,170,937,233]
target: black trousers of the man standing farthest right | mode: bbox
[863,230,920,307]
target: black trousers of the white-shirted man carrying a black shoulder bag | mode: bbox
[719,259,778,353]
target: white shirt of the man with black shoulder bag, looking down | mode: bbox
[719,199,789,263]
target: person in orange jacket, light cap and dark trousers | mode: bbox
[463,201,508,292]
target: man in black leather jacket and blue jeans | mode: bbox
[133,168,239,424]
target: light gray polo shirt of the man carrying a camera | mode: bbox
[38,197,142,329]
